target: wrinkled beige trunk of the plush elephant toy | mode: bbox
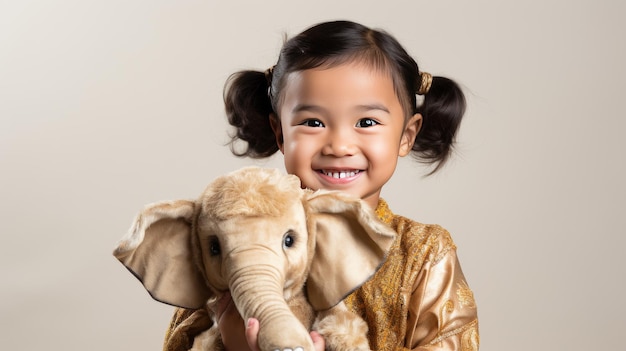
[230,264,313,351]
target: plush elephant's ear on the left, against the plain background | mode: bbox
[113,200,211,308]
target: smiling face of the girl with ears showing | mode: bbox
[272,63,421,208]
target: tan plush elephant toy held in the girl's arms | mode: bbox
[113,167,395,351]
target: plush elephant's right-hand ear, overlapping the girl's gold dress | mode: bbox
[306,191,396,311]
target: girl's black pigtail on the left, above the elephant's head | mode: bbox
[224,71,278,158]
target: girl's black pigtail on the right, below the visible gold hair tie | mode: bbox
[413,75,465,175]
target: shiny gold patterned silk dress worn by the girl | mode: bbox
[163,199,479,351]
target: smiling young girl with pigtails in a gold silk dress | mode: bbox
[164,21,479,351]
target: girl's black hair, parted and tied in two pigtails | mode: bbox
[224,21,465,174]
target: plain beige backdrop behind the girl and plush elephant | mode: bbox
[0,0,626,351]
